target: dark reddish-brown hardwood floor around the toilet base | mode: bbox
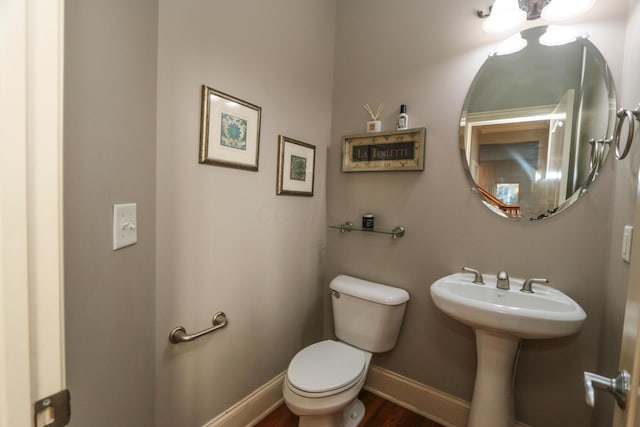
[256,390,443,427]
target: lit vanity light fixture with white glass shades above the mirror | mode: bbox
[477,0,596,33]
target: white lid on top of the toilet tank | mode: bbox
[329,274,409,305]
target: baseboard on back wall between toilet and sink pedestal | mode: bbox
[364,365,528,427]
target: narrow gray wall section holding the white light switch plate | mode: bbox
[64,0,158,427]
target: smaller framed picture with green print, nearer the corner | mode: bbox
[276,135,316,196]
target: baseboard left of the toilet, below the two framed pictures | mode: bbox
[202,371,286,427]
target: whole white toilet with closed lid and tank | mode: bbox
[282,275,409,427]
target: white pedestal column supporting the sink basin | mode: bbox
[467,329,520,427]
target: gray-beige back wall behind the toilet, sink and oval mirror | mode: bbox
[327,0,626,427]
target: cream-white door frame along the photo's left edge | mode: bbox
[0,0,66,426]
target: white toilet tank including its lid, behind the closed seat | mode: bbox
[329,274,409,353]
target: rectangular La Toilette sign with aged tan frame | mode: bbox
[342,127,427,172]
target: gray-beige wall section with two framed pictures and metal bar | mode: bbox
[156,0,335,427]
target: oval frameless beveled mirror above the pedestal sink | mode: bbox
[460,26,616,221]
